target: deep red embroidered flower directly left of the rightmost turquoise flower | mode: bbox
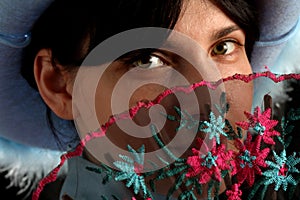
[231,133,270,186]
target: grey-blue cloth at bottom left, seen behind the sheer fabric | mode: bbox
[60,157,174,200]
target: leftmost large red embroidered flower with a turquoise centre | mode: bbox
[186,138,233,184]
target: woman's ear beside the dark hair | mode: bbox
[34,49,73,120]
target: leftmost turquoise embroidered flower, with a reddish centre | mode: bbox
[113,146,150,197]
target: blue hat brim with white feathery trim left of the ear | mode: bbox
[0,0,78,193]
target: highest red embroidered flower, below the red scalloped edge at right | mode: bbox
[236,107,280,145]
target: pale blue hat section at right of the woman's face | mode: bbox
[251,0,300,72]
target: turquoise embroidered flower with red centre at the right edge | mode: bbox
[263,150,300,191]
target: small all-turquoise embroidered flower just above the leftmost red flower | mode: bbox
[201,112,227,144]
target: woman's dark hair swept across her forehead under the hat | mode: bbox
[21,0,258,89]
